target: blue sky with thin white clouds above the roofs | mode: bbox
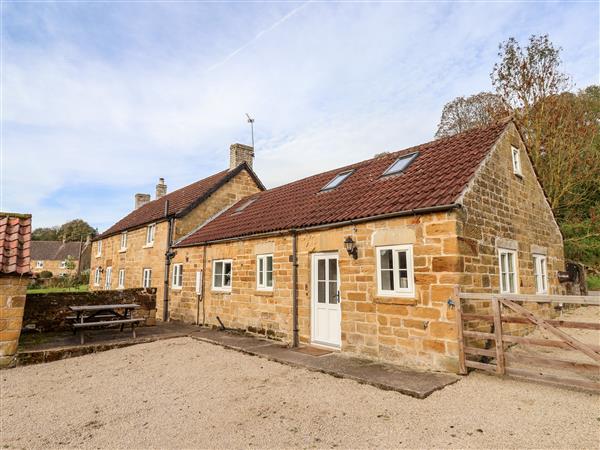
[0,2,600,230]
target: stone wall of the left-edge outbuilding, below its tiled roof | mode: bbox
[0,274,29,368]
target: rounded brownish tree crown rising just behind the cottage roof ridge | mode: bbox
[435,92,509,138]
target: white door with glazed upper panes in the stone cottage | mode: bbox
[311,253,342,348]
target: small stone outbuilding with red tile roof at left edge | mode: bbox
[0,212,31,368]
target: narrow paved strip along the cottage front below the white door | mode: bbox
[190,328,459,398]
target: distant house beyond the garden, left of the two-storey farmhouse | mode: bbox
[31,241,90,276]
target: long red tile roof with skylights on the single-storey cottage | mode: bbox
[176,122,507,246]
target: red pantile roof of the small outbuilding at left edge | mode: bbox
[0,212,31,275]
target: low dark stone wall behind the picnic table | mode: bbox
[23,288,156,331]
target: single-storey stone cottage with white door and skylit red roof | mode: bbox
[168,122,564,371]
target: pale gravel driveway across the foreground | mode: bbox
[0,338,600,448]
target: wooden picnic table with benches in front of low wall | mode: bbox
[67,303,145,344]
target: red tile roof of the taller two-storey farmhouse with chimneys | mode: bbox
[93,163,264,241]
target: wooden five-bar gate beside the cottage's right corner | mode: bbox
[456,293,600,391]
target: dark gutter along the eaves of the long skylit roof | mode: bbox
[176,203,462,248]
